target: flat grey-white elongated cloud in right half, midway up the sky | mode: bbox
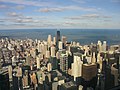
[65,14,112,20]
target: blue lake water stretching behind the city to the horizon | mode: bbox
[0,29,120,45]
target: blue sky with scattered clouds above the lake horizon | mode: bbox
[0,0,120,29]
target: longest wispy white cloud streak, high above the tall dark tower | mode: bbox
[37,6,96,12]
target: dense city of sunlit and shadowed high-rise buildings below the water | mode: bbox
[0,31,120,90]
